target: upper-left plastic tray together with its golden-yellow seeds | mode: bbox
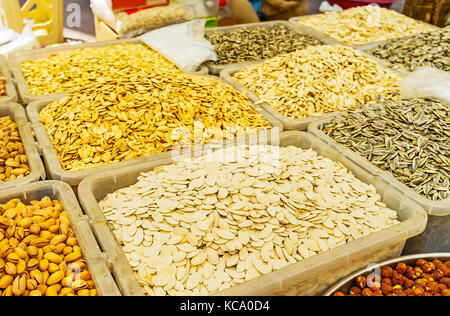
[10,39,207,104]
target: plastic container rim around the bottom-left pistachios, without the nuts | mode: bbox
[0,181,120,296]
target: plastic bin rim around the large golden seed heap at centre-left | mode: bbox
[27,90,283,186]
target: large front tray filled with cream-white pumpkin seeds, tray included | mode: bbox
[79,132,426,296]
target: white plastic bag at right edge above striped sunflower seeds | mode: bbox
[400,67,450,103]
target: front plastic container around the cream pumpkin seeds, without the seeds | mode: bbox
[79,132,427,296]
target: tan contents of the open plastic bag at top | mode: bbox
[115,3,190,37]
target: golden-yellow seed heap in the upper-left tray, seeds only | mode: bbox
[20,44,181,95]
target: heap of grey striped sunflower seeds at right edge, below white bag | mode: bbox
[323,99,450,200]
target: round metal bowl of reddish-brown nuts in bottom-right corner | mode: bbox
[324,252,450,296]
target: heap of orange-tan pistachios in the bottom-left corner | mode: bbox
[0,197,97,296]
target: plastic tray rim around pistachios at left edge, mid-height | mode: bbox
[0,102,45,191]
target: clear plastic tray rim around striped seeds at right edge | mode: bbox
[308,118,450,216]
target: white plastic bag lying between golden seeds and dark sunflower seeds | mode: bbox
[139,20,217,72]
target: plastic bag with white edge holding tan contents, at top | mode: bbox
[91,0,192,38]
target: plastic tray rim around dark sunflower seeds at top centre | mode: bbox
[206,21,338,76]
